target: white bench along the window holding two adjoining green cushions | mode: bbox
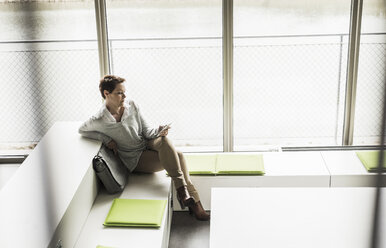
[173,152,330,211]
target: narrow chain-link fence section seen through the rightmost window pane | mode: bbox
[354,34,386,145]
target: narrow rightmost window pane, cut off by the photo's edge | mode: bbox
[353,0,386,145]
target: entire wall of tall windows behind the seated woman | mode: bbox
[0,0,386,151]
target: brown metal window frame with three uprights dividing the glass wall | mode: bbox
[95,0,381,152]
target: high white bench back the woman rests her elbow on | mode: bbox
[0,123,100,248]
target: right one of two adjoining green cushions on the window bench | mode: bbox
[216,153,264,175]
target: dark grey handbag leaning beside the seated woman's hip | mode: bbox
[92,145,129,194]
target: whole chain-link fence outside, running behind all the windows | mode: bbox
[0,35,386,150]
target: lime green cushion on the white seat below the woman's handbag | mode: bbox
[103,198,167,227]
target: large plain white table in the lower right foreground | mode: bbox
[210,188,386,248]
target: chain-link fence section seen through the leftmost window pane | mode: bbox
[0,42,101,145]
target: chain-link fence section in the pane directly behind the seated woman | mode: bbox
[112,39,223,151]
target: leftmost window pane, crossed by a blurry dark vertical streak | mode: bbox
[0,1,101,146]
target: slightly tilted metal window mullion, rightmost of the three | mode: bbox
[343,0,363,145]
